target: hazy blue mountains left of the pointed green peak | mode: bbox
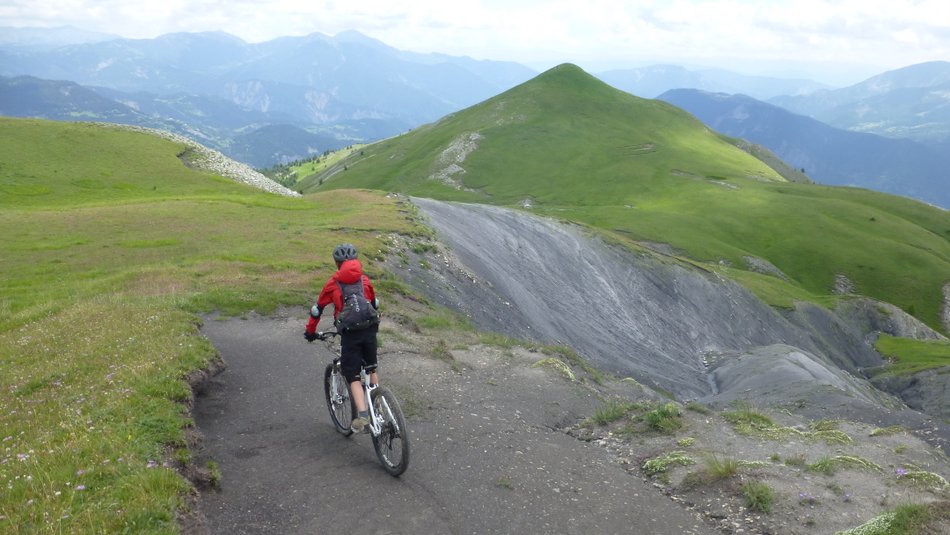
[0,29,536,166]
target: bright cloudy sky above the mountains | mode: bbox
[0,0,950,86]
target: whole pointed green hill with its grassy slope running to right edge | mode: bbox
[297,61,950,330]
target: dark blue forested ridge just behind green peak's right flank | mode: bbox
[659,89,950,209]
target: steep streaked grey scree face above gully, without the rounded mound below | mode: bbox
[397,199,848,398]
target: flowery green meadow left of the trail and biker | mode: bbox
[0,118,413,533]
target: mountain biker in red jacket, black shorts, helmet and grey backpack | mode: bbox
[304,243,379,433]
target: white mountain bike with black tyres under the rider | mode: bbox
[317,331,409,477]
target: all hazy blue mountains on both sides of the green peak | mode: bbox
[0,28,950,207]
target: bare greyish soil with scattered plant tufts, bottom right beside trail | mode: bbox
[568,400,950,535]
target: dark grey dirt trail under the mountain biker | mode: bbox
[195,315,717,535]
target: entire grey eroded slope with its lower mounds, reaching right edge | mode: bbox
[398,199,950,447]
